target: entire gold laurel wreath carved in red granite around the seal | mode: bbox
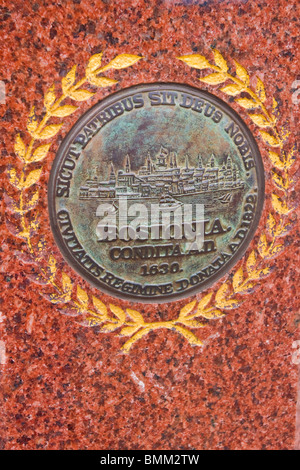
[5,50,295,353]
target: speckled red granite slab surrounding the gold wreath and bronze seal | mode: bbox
[0,0,300,450]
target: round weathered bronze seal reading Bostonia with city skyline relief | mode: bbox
[48,83,264,303]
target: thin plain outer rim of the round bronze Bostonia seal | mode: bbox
[48,82,265,304]
